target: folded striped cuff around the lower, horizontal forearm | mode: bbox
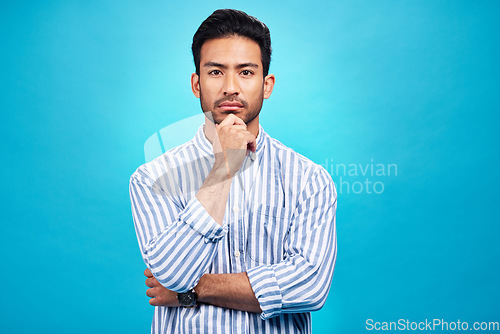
[247,265,283,320]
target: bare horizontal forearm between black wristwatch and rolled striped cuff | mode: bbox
[195,272,262,313]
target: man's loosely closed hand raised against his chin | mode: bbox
[213,114,256,177]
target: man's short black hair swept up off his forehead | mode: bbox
[191,9,271,76]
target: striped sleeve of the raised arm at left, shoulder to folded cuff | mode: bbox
[129,166,227,292]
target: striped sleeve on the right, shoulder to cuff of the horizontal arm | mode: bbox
[247,168,337,320]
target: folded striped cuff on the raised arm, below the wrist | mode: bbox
[179,196,227,243]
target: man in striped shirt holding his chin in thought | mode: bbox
[130,9,337,333]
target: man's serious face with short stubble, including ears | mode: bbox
[191,36,274,125]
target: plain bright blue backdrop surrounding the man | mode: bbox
[0,0,500,333]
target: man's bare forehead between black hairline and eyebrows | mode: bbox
[200,36,262,66]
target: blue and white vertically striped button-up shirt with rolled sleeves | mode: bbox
[130,125,337,334]
